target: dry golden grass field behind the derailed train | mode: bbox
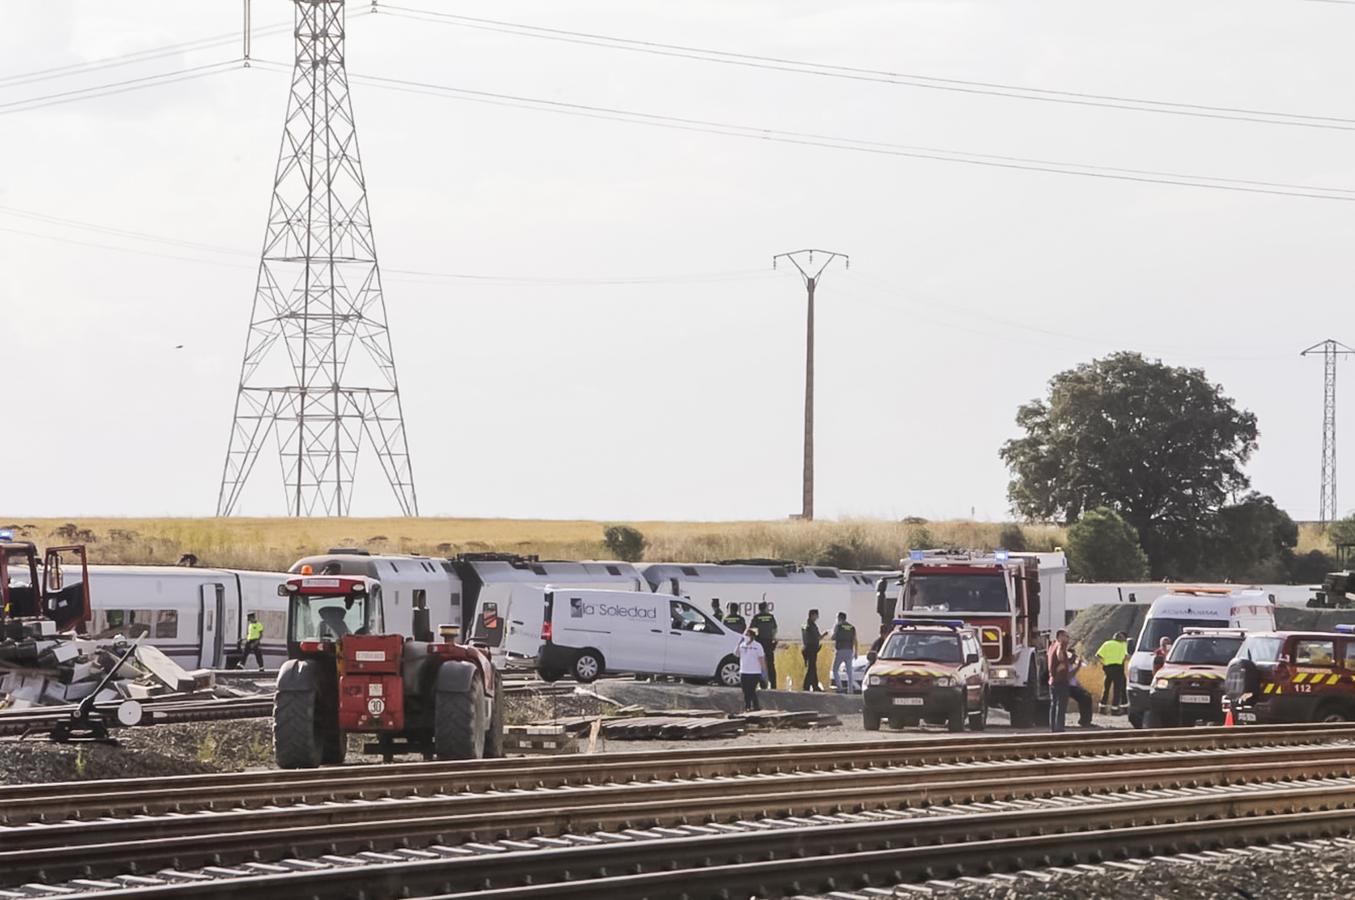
[0,516,1064,569]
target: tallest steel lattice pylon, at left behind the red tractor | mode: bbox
[217,0,419,515]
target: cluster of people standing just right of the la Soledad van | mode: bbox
[710,599,856,712]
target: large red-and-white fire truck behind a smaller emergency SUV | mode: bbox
[898,550,1068,728]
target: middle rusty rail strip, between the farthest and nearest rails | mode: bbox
[0,748,1355,884]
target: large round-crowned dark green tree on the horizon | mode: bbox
[1001,352,1257,576]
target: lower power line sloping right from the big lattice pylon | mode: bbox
[256,60,1355,201]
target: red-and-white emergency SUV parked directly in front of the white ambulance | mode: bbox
[1145,628,1247,728]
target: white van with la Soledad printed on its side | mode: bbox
[537,586,741,687]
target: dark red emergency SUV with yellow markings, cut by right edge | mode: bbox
[1224,625,1355,725]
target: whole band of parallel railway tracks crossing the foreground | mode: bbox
[0,727,1355,900]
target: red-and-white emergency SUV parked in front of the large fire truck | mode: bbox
[862,619,988,732]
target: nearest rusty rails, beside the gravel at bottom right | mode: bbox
[45,782,1355,900]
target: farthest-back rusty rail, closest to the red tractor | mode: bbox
[0,724,1355,824]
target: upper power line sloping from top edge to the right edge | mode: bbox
[382,5,1355,131]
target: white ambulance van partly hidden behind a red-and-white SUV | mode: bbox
[1125,586,1275,728]
